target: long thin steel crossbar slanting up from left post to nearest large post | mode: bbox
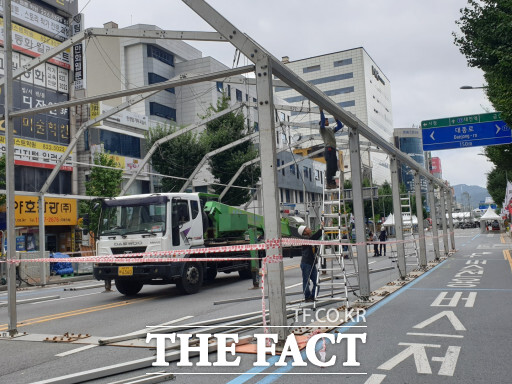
[12,65,254,117]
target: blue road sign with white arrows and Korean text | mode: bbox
[422,114,512,151]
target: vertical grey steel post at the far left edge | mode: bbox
[2,0,18,336]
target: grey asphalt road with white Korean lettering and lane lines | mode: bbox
[0,230,512,384]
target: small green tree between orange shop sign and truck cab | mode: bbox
[80,153,123,236]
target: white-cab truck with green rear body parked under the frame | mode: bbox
[93,193,300,295]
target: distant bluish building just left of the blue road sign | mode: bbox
[393,128,427,193]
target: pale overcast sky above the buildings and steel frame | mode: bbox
[79,0,493,187]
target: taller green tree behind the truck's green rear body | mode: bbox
[201,95,260,206]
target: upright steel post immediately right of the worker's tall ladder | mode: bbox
[350,128,371,301]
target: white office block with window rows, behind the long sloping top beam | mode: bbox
[275,48,393,184]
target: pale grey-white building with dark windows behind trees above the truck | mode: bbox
[83,22,257,193]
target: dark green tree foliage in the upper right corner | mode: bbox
[453,0,512,125]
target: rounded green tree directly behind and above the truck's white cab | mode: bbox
[146,125,208,192]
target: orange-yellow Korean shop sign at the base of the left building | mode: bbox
[14,196,78,227]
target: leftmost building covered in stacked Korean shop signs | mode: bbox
[0,0,78,252]
